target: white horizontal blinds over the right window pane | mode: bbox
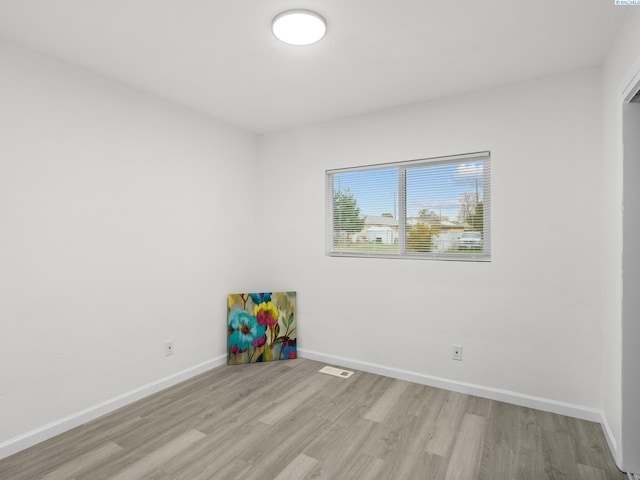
[406,156,488,254]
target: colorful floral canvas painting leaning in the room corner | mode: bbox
[227,292,297,365]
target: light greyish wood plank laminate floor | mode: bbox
[0,359,627,480]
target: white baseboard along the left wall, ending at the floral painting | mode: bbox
[0,355,227,459]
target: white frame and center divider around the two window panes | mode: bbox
[326,151,491,262]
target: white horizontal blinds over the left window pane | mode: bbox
[332,167,400,255]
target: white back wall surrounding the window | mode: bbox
[259,70,609,408]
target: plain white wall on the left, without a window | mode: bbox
[0,43,258,444]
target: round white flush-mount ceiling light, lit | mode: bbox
[271,10,327,45]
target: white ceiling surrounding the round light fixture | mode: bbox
[0,0,629,133]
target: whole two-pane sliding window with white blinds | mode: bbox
[327,152,491,261]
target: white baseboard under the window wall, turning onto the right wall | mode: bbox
[298,348,615,426]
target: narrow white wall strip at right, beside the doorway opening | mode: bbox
[602,8,640,466]
